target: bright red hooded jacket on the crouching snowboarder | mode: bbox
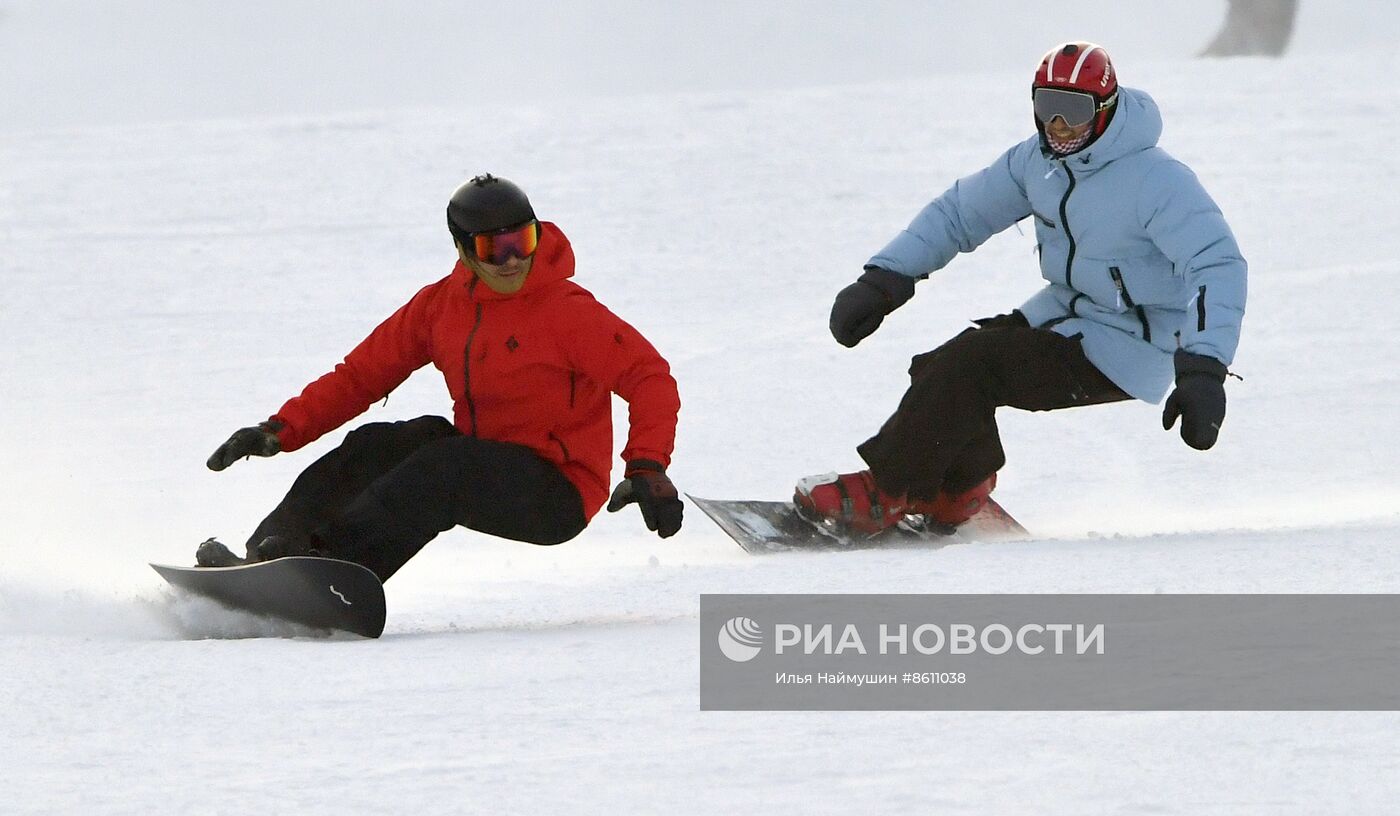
[272,221,680,518]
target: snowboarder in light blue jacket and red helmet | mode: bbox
[794,42,1246,532]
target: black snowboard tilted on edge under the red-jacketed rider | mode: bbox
[151,556,385,637]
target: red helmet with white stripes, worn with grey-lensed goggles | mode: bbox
[1030,42,1119,154]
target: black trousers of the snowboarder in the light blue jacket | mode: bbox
[857,325,1130,500]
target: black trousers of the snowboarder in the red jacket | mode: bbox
[248,416,588,581]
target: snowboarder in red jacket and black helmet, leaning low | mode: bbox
[196,175,682,579]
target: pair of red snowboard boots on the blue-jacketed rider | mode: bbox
[792,470,997,535]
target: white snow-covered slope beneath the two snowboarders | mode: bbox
[0,3,1400,813]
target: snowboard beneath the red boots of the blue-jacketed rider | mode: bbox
[686,494,1030,554]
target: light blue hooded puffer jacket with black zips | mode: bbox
[869,88,1246,402]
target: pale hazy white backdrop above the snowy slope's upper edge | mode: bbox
[0,0,1310,130]
